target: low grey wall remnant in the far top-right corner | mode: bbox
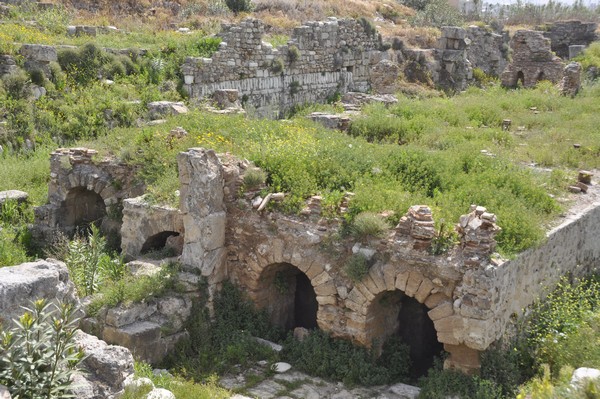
[543,20,598,60]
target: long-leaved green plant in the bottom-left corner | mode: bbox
[0,299,84,398]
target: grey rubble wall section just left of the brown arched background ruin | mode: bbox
[467,25,509,77]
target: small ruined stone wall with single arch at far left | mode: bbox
[32,148,144,244]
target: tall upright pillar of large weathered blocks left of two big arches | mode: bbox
[177,148,226,285]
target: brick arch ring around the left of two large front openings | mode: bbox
[238,239,337,330]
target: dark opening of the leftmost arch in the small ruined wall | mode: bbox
[64,187,106,232]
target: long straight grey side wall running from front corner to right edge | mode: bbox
[455,195,600,348]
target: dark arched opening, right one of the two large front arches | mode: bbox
[367,290,444,378]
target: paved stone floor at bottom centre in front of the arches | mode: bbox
[220,362,419,399]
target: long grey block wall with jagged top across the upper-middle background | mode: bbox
[182,18,380,117]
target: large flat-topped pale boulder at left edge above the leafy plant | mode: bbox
[0,259,77,323]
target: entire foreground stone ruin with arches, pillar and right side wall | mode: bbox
[29,148,600,372]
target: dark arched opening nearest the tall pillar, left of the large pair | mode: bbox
[255,263,319,331]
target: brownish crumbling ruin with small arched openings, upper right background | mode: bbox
[502,30,565,87]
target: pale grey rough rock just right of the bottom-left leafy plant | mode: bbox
[74,331,133,399]
